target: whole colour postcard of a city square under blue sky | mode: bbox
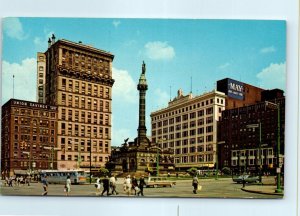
[1,17,286,199]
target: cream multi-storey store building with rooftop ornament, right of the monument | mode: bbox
[151,90,226,169]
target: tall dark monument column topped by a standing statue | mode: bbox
[137,61,148,145]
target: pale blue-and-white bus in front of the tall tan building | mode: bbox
[40,170,86,184]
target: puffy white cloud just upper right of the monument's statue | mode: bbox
[145,41,175,60]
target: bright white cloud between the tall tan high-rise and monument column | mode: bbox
[113,68,138,103]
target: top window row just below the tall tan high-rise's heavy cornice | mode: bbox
[61,78,111,98]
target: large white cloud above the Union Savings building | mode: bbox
[2,58,36,104]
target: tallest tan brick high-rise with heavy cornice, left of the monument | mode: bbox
[45,35,114,169]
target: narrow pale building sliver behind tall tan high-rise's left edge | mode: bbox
[36,52,46,103]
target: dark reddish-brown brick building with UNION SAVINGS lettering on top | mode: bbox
[1,99,57,177]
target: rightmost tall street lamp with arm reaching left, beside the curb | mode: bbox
[265,101,282,193]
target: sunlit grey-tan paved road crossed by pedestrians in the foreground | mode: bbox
[1,178,281,199]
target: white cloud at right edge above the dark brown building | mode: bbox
[256,62,286,90]
